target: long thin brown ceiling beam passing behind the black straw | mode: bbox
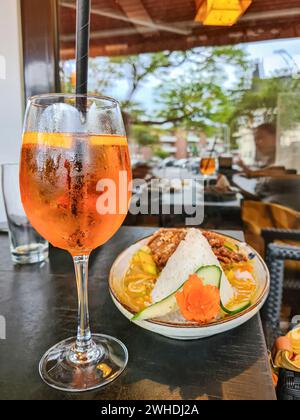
[60,1,191,36]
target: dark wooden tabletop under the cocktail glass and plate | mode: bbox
[0,227,275,400]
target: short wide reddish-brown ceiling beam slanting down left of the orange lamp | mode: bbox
[117,0,159,37]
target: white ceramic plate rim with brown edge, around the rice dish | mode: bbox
[109,233,270,340]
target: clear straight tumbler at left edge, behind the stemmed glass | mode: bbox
[1,164,49,264]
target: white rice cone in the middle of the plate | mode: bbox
[152,229,234,305]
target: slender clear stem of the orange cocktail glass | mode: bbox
[72,255,94,362]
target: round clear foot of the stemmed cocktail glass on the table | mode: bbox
[39,335,128,392]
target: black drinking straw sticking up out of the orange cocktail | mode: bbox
[76,0,91,111]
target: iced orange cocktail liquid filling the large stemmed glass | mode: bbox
[21,133,131,255]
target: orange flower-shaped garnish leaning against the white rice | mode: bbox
[176,274,221,324]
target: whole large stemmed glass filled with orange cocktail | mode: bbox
[20,94,131,392]
